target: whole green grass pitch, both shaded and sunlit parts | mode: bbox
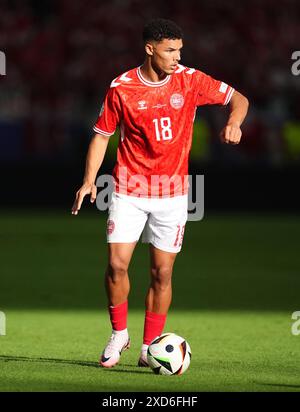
[0,210,300,392]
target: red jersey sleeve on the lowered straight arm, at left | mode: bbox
[93,88,121,137]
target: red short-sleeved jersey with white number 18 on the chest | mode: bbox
[94,64,234,197]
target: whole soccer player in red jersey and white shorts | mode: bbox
[72,19,248,367]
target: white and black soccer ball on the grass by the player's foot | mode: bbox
[147,333,192,375]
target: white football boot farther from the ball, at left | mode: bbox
[99,329,130,368]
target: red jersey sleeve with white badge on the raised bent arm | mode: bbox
[194,70,234,106]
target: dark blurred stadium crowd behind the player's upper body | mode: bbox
[0,0,300,166]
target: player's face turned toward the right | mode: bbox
[148,39,183,74]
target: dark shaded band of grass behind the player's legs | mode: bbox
[0,214,300,313]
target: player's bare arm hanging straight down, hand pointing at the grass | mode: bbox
[72,133,109,215]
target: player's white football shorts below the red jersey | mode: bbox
[107,192,188,253]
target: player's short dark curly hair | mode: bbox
[143,19,183,43]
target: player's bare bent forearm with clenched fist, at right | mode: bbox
[220,90,249,144]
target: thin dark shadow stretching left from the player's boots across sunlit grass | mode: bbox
[0,355,151,373]
